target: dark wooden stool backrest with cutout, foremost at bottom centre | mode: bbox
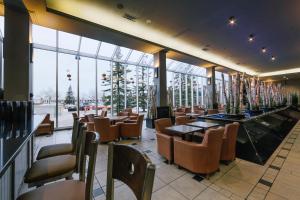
[106,143,155,200]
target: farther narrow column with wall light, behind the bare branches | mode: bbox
[206,66,218,109]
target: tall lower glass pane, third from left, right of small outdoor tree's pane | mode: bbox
[79,57,96,115]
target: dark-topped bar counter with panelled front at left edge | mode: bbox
[0,115,45,200]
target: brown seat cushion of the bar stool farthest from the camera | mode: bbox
[36,143,73,160]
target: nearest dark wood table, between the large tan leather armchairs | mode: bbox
[165,125,203,141]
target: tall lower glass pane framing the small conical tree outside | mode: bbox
[58,53,78,127]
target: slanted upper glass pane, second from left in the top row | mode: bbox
[58,31,79,51]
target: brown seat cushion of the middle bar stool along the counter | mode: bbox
[24,155,76,183]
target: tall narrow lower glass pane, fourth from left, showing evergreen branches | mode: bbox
[97,60,111,115]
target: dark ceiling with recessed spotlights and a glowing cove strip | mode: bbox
[19,0,300,77]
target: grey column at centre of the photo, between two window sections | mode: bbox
[153,50,168,106]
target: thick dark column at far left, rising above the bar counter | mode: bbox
[3,1,32,101]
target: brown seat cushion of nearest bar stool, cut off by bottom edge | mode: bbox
[17,180,85,200]
